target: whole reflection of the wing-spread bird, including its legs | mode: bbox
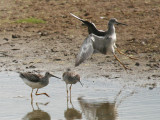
[78,86,135,120]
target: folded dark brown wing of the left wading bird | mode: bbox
[19,73,40,82]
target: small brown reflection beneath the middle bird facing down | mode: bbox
[64,94,82,120]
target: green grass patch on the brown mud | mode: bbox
[15,18,46,24]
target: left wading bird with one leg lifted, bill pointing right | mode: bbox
[20,72,61,99]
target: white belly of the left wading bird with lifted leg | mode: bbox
[23,79,45,89]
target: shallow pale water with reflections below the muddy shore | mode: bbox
[0,73,160,120]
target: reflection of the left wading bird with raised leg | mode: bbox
[22,103,51,120]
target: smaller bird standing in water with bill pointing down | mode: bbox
[63,69,83,101]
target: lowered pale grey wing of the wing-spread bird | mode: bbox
[75,34,94,66]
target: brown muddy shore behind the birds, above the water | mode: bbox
[0,0,160,80]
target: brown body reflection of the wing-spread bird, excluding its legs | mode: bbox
[78,97,117,120]
